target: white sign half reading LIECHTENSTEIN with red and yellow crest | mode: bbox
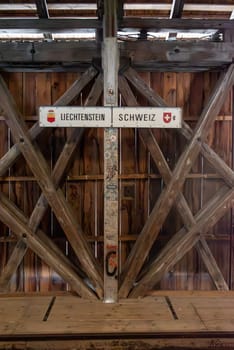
[39,106,112,128]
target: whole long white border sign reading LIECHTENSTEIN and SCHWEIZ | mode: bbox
[39,106,182,128]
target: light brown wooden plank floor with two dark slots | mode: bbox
[0,292,234,349]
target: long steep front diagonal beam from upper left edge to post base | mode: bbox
[0,74,103,298]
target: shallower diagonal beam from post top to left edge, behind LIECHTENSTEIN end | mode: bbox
[0,66,97,176]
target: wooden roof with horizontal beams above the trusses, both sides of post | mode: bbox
[0,0,234,71]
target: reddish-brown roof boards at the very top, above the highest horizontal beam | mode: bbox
[0,0,234,19]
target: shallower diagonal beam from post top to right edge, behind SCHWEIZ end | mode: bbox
[124,68,234,187]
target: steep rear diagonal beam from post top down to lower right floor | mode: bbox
[119,77,228,290]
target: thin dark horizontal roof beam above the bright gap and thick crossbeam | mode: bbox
[0,17,234,33]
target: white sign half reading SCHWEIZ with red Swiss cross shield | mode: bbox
[112,107,182,128]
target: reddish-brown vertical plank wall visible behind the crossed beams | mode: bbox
[0,72,231,292]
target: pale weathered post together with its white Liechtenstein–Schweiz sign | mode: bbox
[39,105,182,303]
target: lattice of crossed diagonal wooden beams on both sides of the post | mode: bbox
[0,64,234,299]
